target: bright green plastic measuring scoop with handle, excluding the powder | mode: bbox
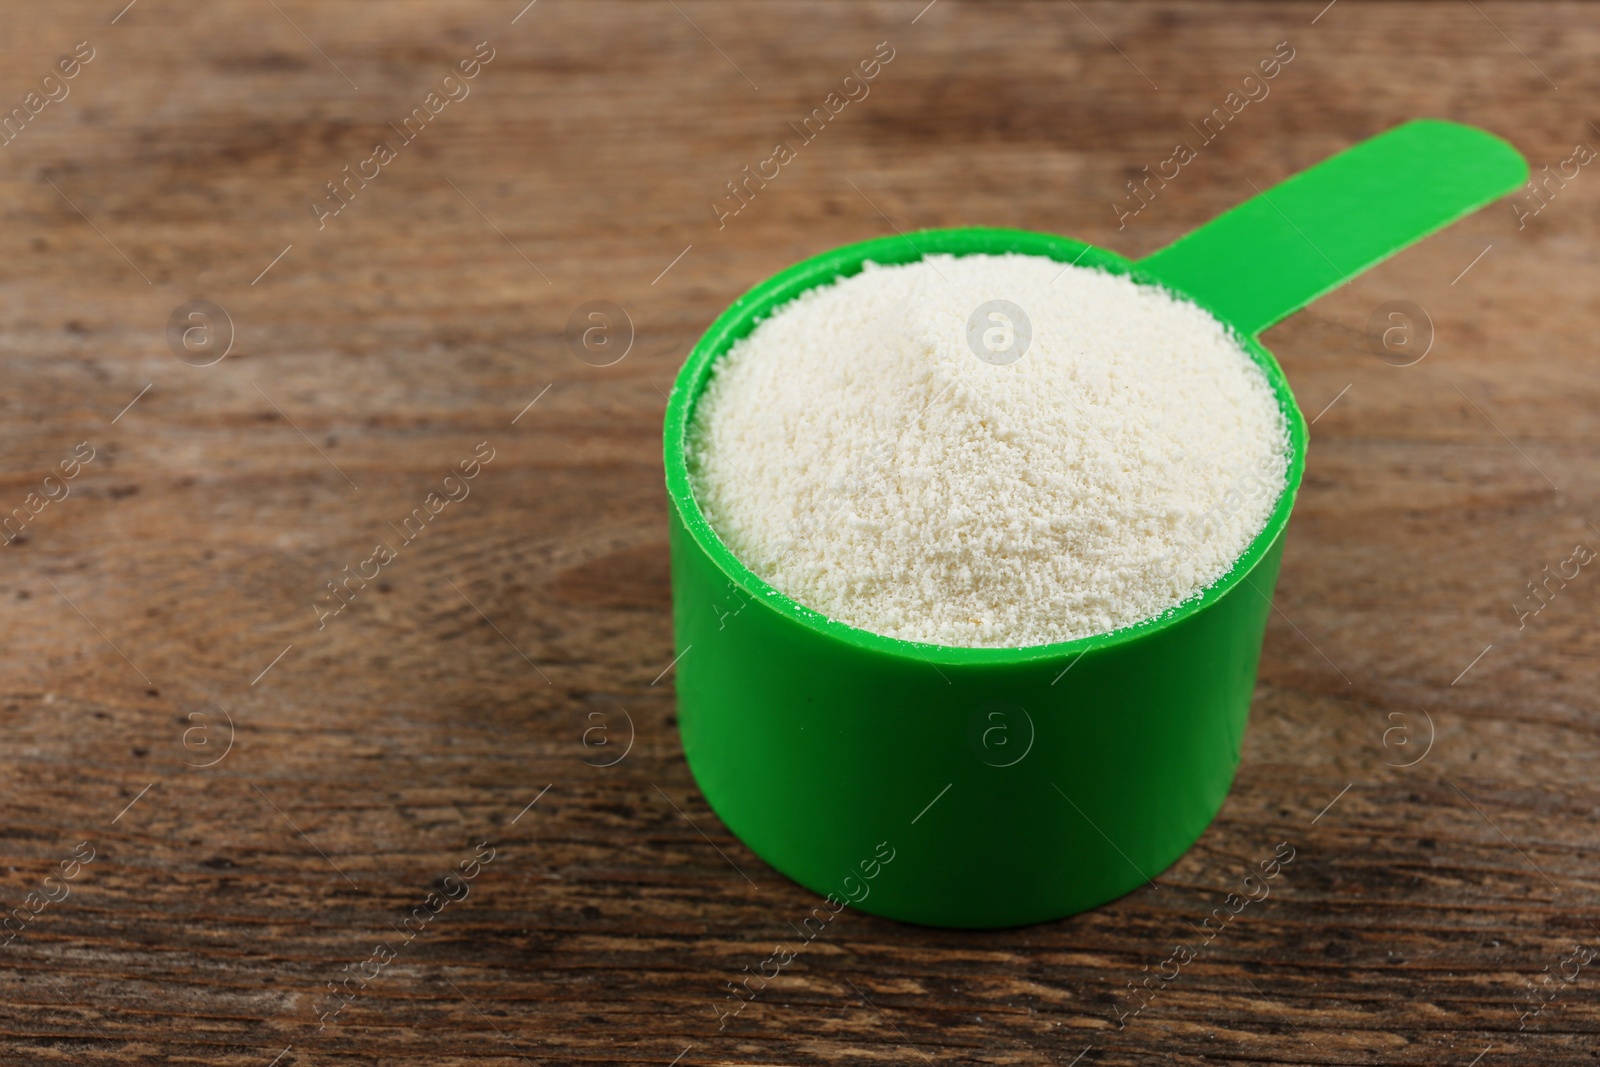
[666,120,1528,936]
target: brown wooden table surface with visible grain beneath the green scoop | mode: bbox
[0,0,1600,1067]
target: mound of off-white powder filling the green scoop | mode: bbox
[688,254,1288,648]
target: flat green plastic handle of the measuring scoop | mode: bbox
[1139,118,1528,336]
